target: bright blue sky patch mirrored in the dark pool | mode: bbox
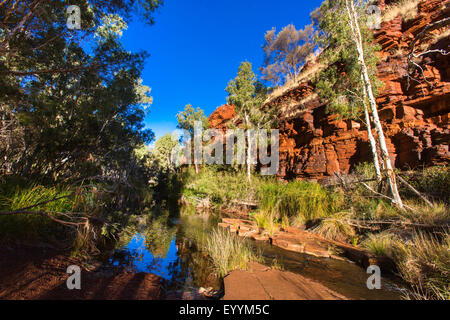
[110,233,180,280]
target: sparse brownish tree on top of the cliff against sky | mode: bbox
[261,24,315,85]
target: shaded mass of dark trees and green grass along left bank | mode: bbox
[0,0,162,249]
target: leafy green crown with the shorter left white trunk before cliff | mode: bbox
[311,2,382,183]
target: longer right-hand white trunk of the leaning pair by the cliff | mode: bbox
[345,0,404,209]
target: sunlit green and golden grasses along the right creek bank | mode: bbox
[183,164,450,299]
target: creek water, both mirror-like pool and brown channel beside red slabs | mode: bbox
[103,213,401,299]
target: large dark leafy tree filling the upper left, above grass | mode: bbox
[0,0,161,179]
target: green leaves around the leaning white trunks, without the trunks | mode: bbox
[311,0,381,119]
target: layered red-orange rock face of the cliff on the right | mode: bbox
[210,0,450,180]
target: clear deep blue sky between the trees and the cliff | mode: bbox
[122,0,322,138]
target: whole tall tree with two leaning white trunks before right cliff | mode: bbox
[312,0,403,208]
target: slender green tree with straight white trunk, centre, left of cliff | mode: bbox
[225,61,275,181]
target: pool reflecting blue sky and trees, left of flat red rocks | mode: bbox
[108,214,220,291]
